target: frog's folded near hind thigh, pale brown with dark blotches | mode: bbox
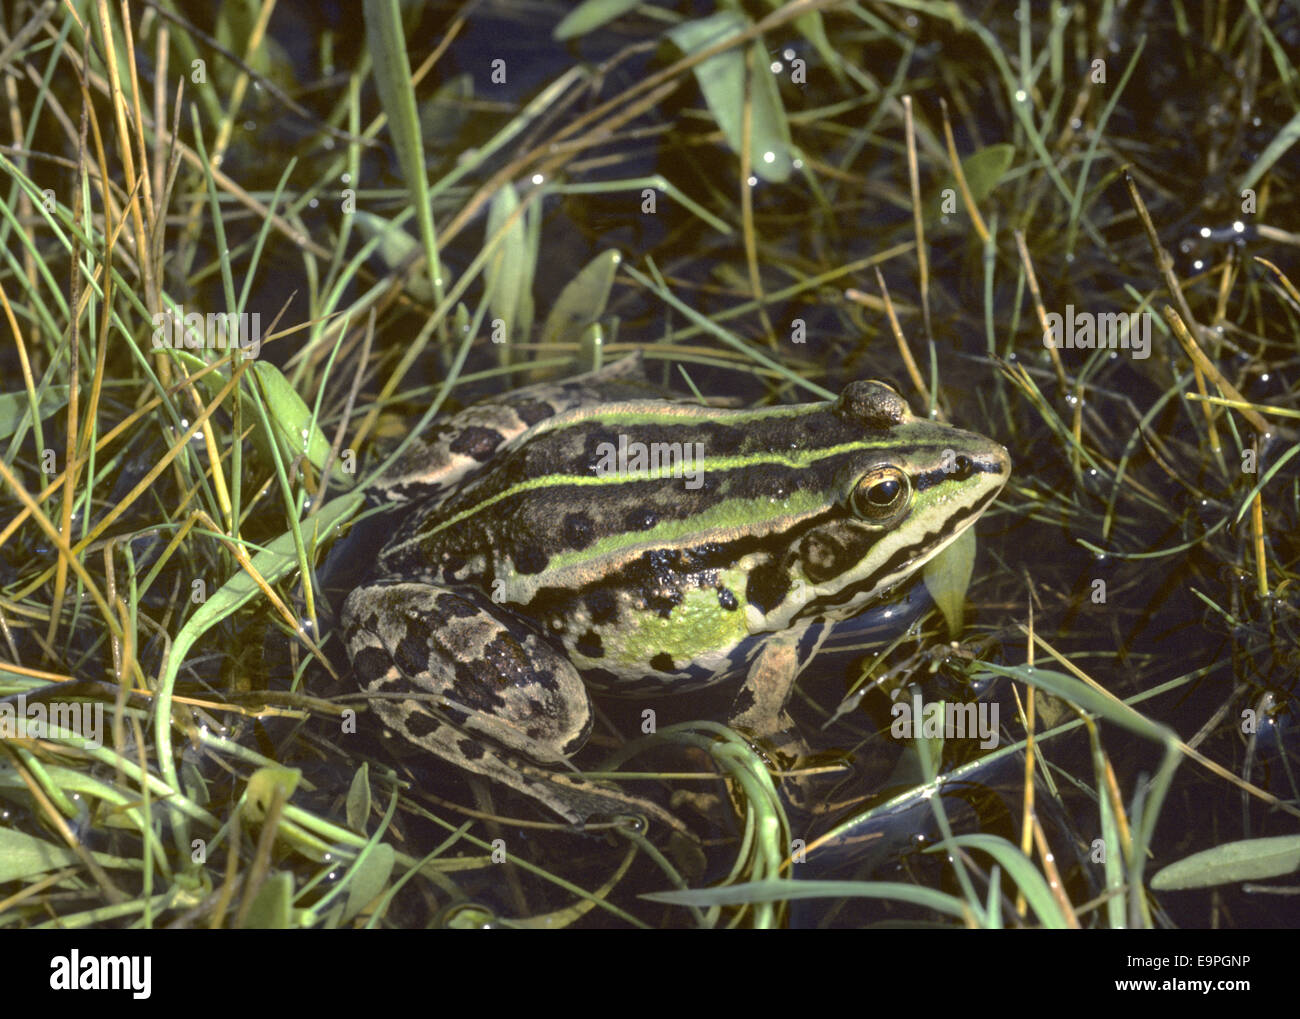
[343,582,592,763]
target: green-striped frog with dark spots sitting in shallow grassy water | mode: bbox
[342,356,1010,823]
